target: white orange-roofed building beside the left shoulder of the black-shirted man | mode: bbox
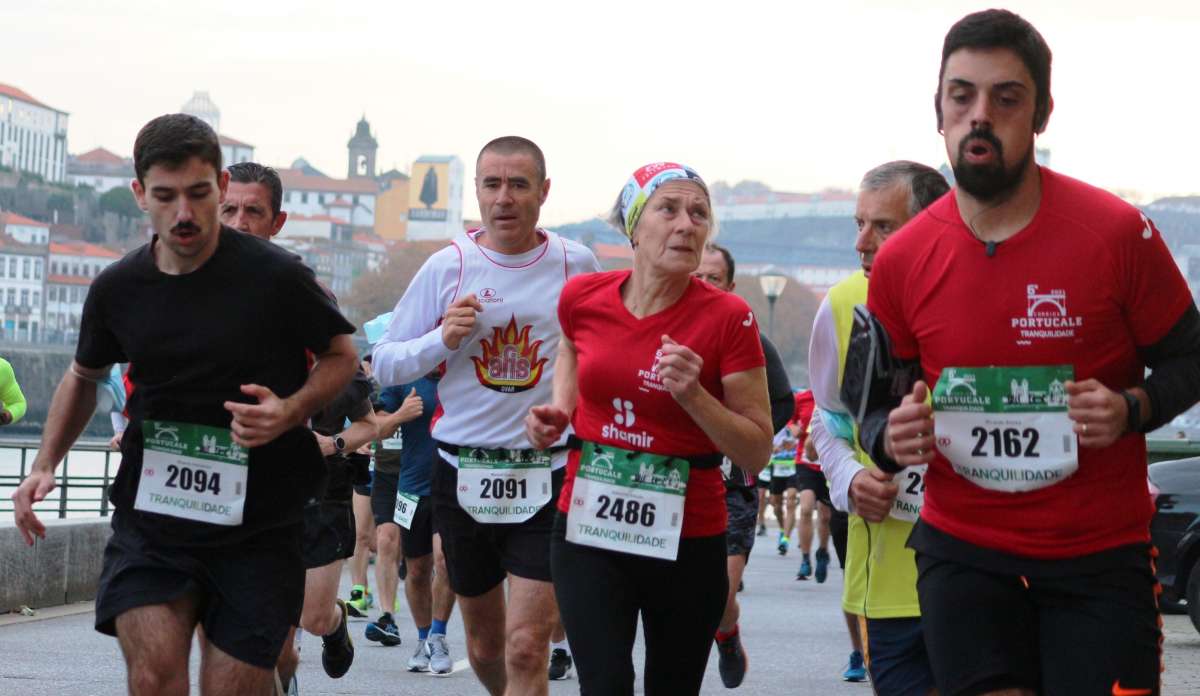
[44,241,121,342]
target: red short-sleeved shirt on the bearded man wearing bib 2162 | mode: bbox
[868,168,1192,559]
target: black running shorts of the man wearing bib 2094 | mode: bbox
[96,511,305,668]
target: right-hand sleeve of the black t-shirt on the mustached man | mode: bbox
[276,258,355,355]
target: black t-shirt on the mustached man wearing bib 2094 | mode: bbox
[76,227,354,545]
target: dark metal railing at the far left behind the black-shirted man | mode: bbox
[0,438,120,520]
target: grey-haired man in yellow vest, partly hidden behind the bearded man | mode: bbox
[809,161,949,696]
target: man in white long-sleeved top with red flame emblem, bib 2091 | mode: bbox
[373,136,600,696]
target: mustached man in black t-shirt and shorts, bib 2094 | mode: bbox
[13,114,356,695]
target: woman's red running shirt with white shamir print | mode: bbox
[558,270,766,538]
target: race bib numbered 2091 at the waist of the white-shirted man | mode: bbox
[458,448,551,524]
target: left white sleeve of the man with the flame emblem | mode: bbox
[372,246,461,386]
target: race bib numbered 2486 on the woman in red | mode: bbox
[566,443,690,560]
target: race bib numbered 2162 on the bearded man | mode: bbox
[934,365,1079,493]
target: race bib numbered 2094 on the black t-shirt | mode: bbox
[133,420,250,527]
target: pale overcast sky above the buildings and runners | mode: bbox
[9,0,1200,223]
